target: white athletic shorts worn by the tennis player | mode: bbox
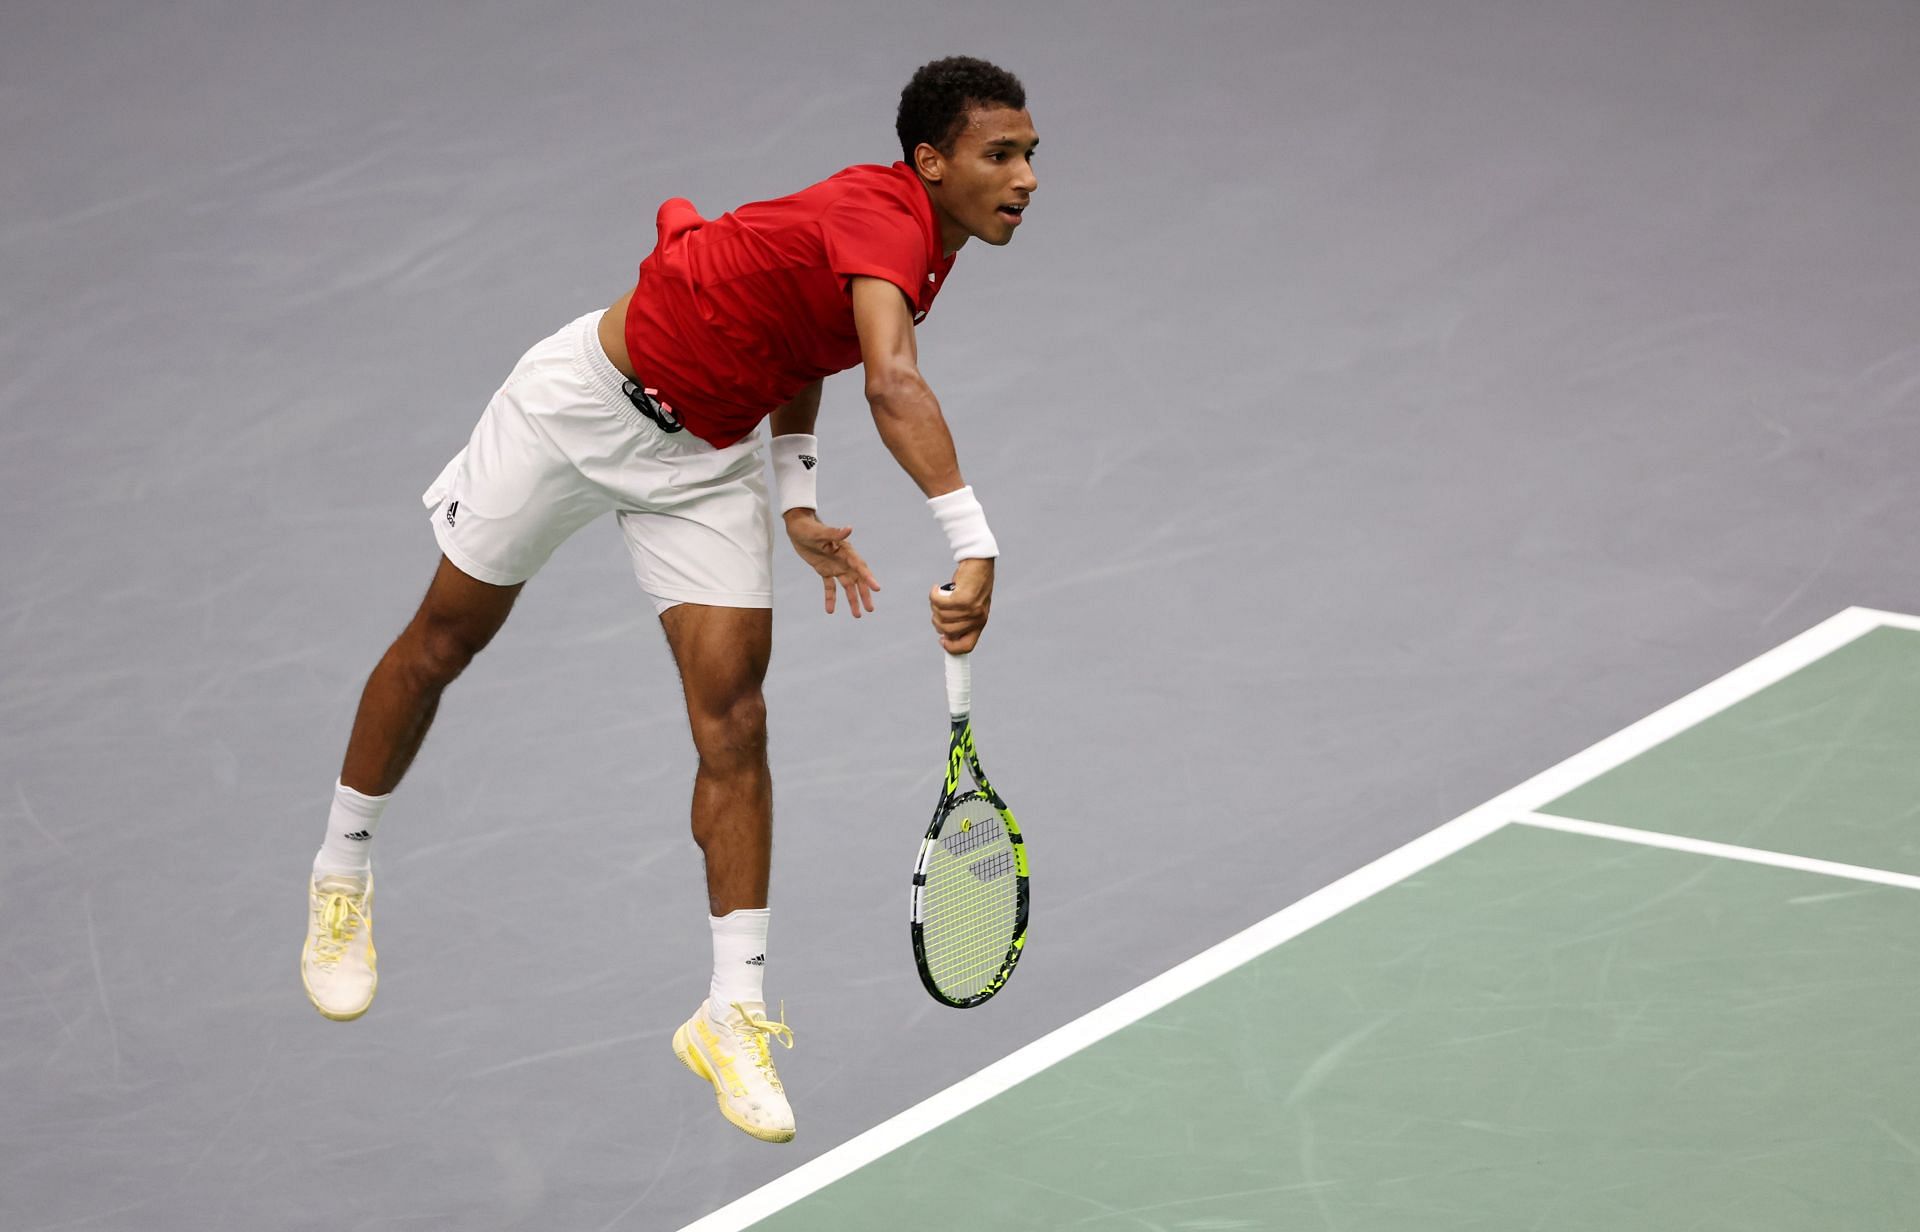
[420,313,774,610]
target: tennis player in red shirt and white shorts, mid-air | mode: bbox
[300,56,1037,1142]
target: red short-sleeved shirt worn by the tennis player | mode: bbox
[626,163,954,449]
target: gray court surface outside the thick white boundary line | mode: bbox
[0,0,1920,1232]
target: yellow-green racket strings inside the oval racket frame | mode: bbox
[922,796,1020,998]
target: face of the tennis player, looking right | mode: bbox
[914,107,1041,251]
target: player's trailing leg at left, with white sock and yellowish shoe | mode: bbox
[300,557,520,1021]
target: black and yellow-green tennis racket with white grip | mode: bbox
[912,654,1027,1009]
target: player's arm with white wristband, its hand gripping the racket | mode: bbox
[852,270,998,654]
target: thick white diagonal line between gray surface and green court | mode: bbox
[682,608,1920,1232]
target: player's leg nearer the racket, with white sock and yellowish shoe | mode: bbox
[660,604,793,1142]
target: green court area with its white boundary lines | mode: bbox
[691,608,1920,1232]
